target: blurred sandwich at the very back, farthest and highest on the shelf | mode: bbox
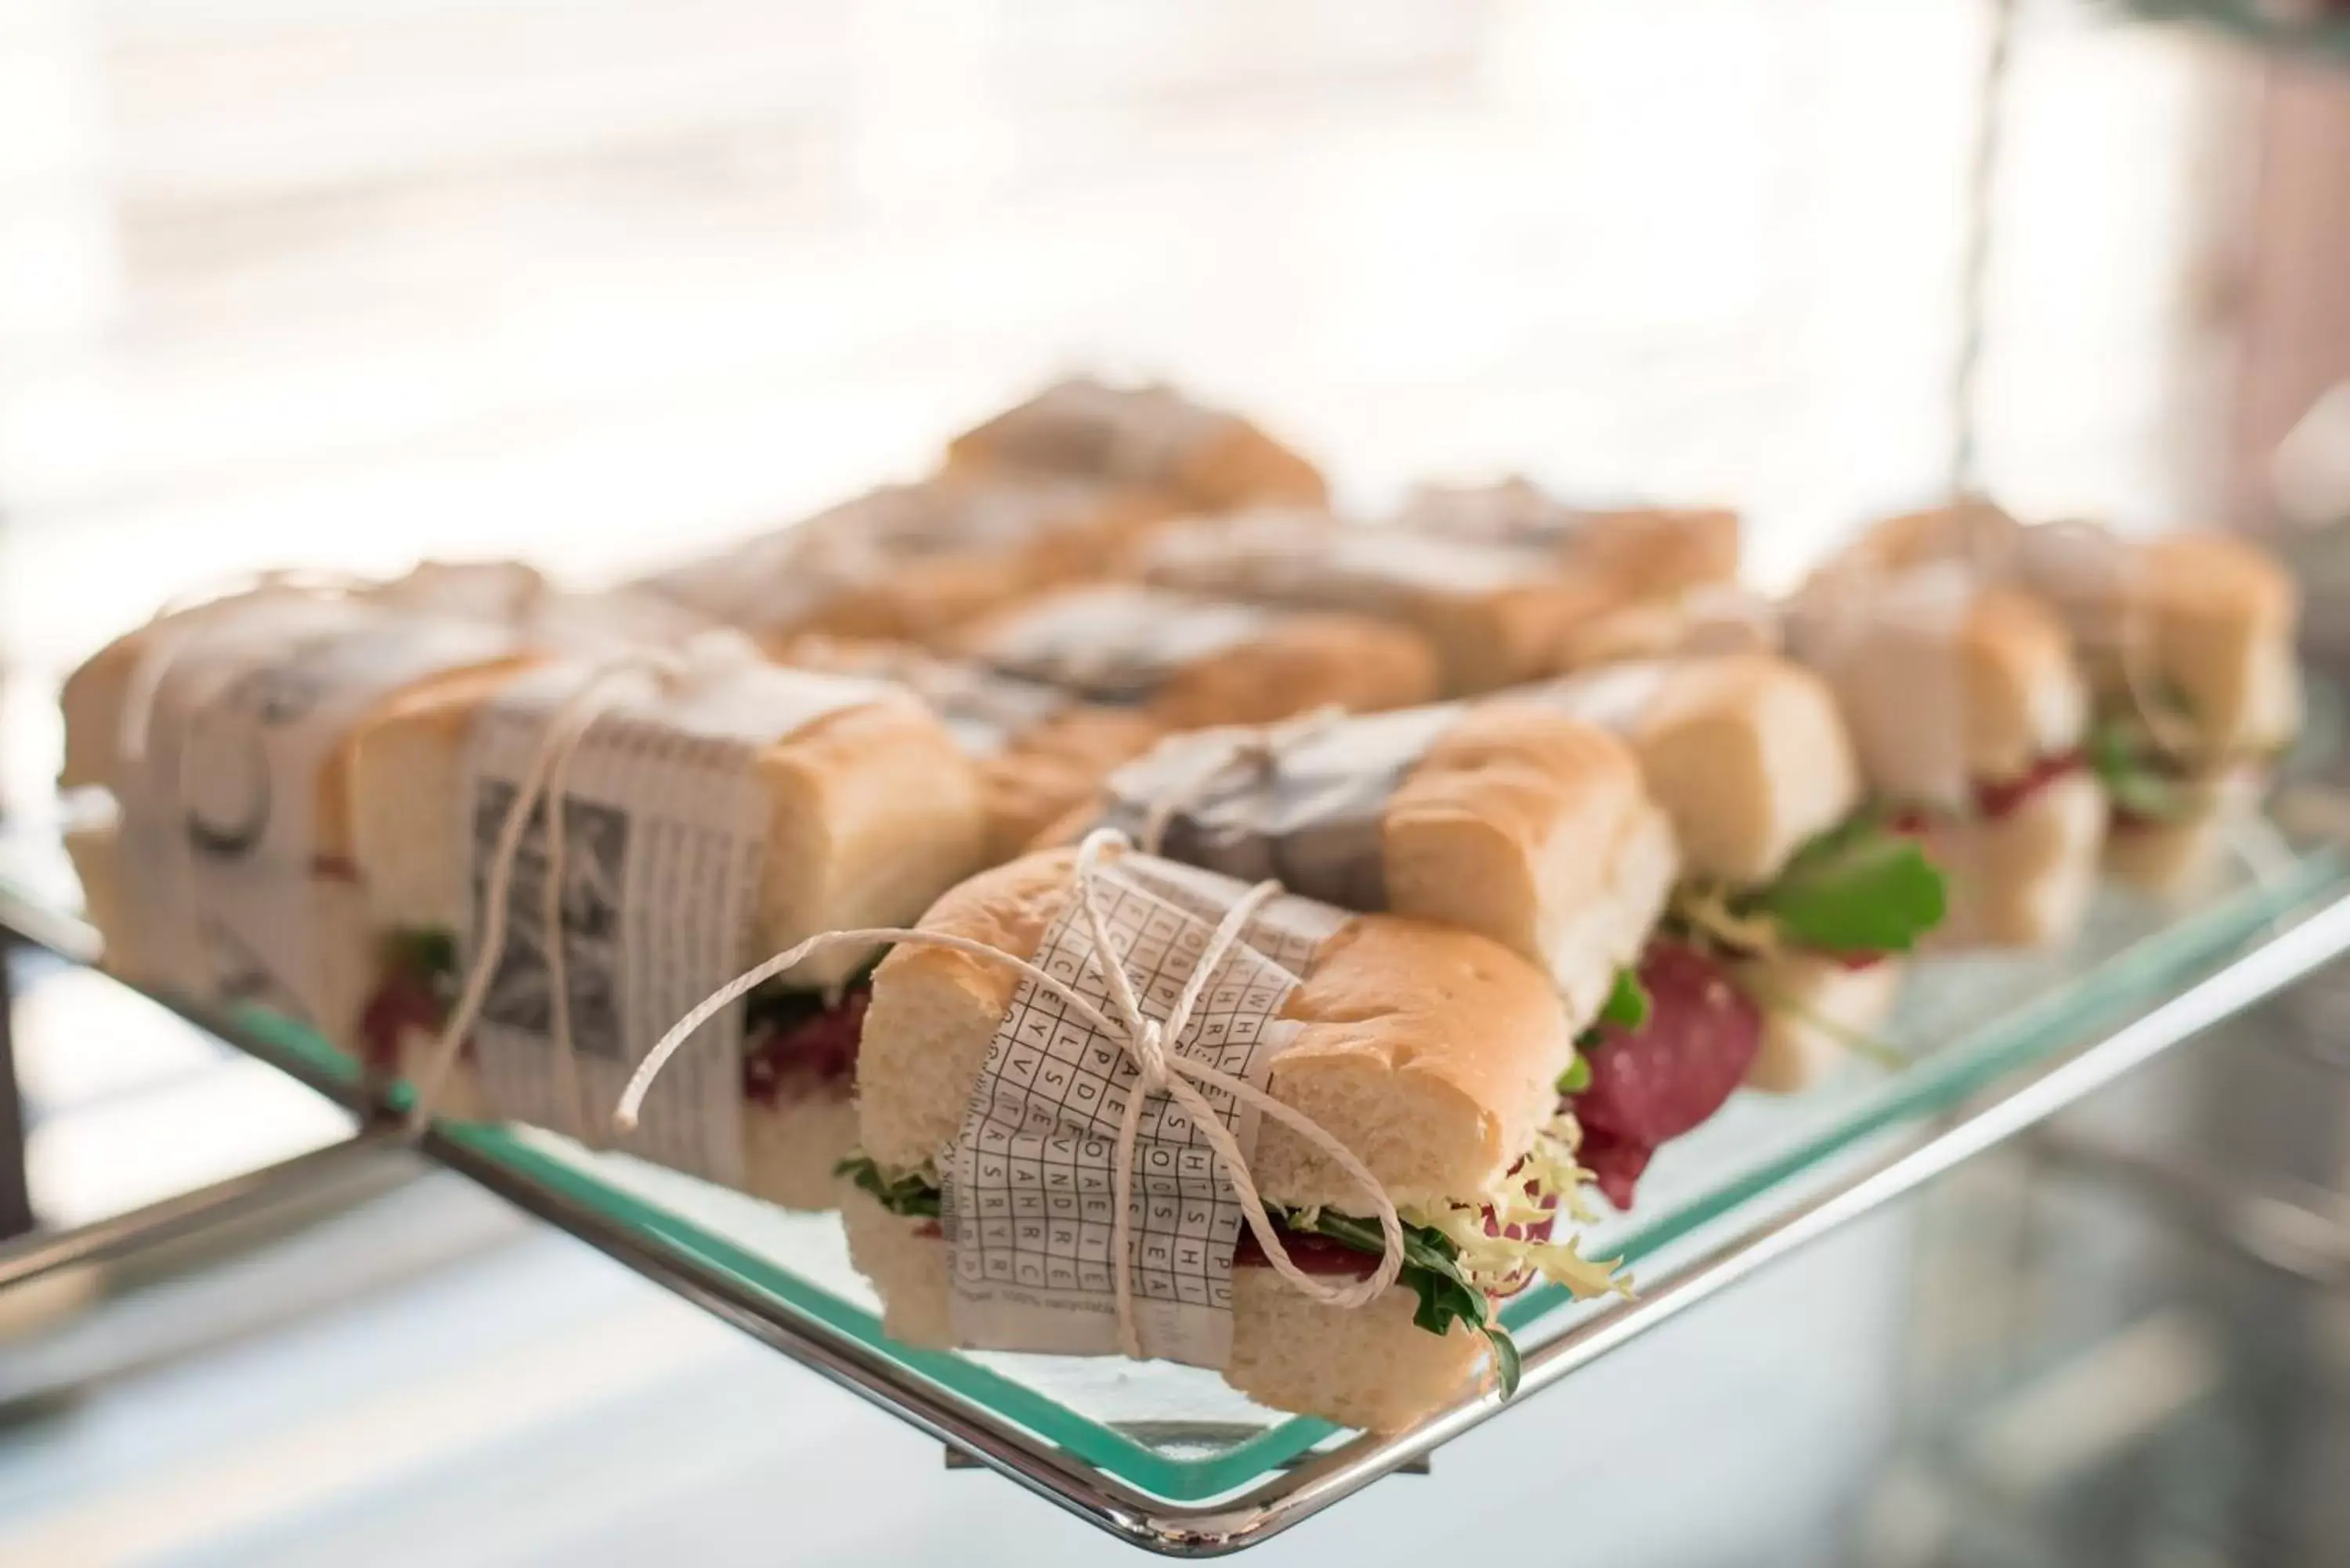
[947,376,1330,512]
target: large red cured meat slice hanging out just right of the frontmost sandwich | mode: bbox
[1570,941,1762,1209]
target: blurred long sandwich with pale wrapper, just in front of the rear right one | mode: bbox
[1140,510,1624,695]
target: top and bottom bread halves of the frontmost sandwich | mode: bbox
[844,851,1572,1429]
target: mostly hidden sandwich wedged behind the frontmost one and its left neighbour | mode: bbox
[783,637,1161,865]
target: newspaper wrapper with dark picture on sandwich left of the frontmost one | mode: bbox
[458,665,905,1185]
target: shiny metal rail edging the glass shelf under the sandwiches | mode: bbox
[0,891,2350,1556]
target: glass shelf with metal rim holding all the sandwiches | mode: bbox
[0,818,2350,1552]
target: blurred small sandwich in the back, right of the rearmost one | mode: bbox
[1394,477,1739,599]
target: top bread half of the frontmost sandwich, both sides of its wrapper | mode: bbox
[858,851,1572,1209]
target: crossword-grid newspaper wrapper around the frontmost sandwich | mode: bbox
[942,856,1347,1366]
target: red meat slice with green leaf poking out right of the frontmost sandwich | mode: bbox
[1558,816,1946,1209]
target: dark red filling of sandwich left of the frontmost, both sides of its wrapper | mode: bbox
[360,931,879,1107]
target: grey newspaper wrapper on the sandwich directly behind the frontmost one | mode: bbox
[1102,705,1459,915]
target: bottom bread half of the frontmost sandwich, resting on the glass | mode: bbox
[841,1187,1485,1432]
